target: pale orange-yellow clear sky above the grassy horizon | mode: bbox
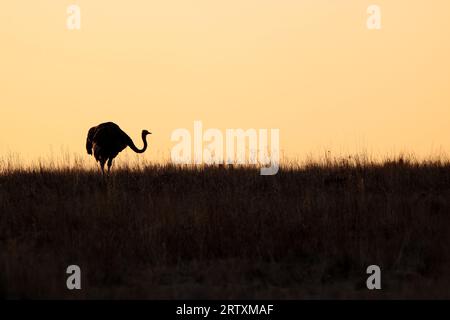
[0,0,450,166]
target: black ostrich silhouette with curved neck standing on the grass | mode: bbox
[86,122,151,174]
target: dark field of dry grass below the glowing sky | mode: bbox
[0,159,450,299]
